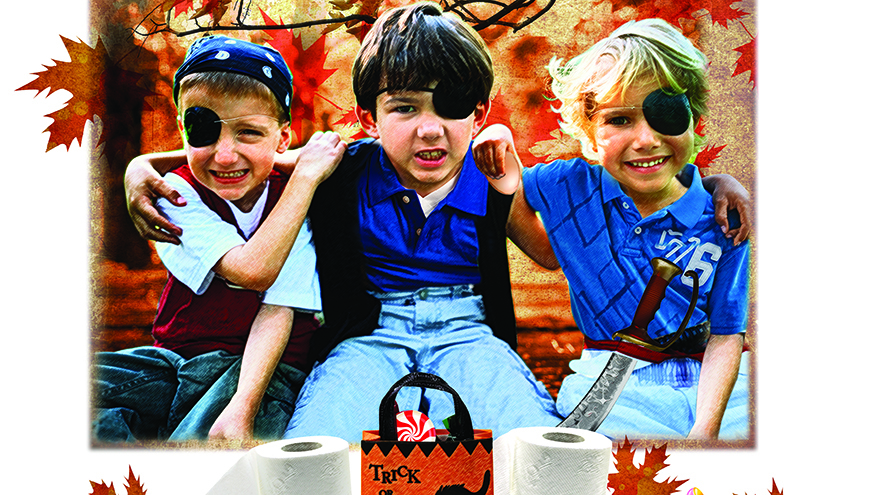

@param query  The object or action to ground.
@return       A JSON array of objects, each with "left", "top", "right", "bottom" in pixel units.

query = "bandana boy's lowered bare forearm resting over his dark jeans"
[{"left": 208, "top": 304, "right": 294, "bottom": 440}]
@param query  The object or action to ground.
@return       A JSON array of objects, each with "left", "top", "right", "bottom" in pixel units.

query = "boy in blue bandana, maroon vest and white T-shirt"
[{"left": 93, "top": 36, "right": 345, "bottom": 442}]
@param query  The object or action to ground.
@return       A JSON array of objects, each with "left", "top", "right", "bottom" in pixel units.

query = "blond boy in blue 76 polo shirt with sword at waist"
[{"left": 475, "top": 19, "right": 749, "bottom": 439}]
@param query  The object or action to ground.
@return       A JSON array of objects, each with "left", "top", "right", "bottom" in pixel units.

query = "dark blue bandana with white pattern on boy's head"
[{"left": 174, "top": 36, "right": 293, "bottom": 120}]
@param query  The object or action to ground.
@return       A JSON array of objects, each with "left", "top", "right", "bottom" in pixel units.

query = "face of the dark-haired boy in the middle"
[{"left": 357, "top": 86, "right": 489, "bottom": 196}]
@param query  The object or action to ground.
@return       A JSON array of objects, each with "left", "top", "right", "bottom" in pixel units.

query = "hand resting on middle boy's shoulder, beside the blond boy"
[{"left": 473, "top": 124, "right": 522, "bottom": 194}]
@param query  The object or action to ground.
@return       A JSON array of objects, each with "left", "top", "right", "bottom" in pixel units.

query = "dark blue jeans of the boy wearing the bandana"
[{"left": 92, "top": 347, "right": 305, "bottom": 442}]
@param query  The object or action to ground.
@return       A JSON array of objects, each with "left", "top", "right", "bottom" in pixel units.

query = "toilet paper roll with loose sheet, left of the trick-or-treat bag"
[{"left": 208, "top": 436, "right": 351, "bottom": 495}]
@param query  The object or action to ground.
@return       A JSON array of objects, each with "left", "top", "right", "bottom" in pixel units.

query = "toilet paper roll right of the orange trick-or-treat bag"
[{"left": 493, "top": 427, "right": 611, "bottom": 495}]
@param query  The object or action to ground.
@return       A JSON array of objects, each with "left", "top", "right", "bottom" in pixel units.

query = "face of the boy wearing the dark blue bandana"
[{"left": 178, "top": 87, "right": 290, "bottom": 211}]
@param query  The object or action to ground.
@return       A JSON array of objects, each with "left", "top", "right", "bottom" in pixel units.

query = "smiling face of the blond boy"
[{"left": 592, "top": 83, "right": 694, "bottom": 207}]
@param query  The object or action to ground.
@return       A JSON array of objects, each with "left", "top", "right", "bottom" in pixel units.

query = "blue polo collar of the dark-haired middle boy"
[{"left": 367, "top": 141, "right": 489, "bottom": 216}]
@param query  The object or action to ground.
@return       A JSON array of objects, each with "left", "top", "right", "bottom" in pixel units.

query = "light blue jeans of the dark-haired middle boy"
[{"left": 284, "top": 286, "right": 561, "bottom": 443}]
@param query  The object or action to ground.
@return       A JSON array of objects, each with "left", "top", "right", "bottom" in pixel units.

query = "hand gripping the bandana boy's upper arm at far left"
[{"left": 124, "top": 156, "right": 186, "bottom": 244}]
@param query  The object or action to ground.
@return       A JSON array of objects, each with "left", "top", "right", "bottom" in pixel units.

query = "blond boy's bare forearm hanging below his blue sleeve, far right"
[{"left": 688, "top": 333, "right": 743, "bottom": 439}]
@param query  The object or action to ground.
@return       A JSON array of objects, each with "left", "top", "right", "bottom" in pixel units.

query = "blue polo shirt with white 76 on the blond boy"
[{"left": 523, "top": 159, "right": 749, "bottom": 340}]
